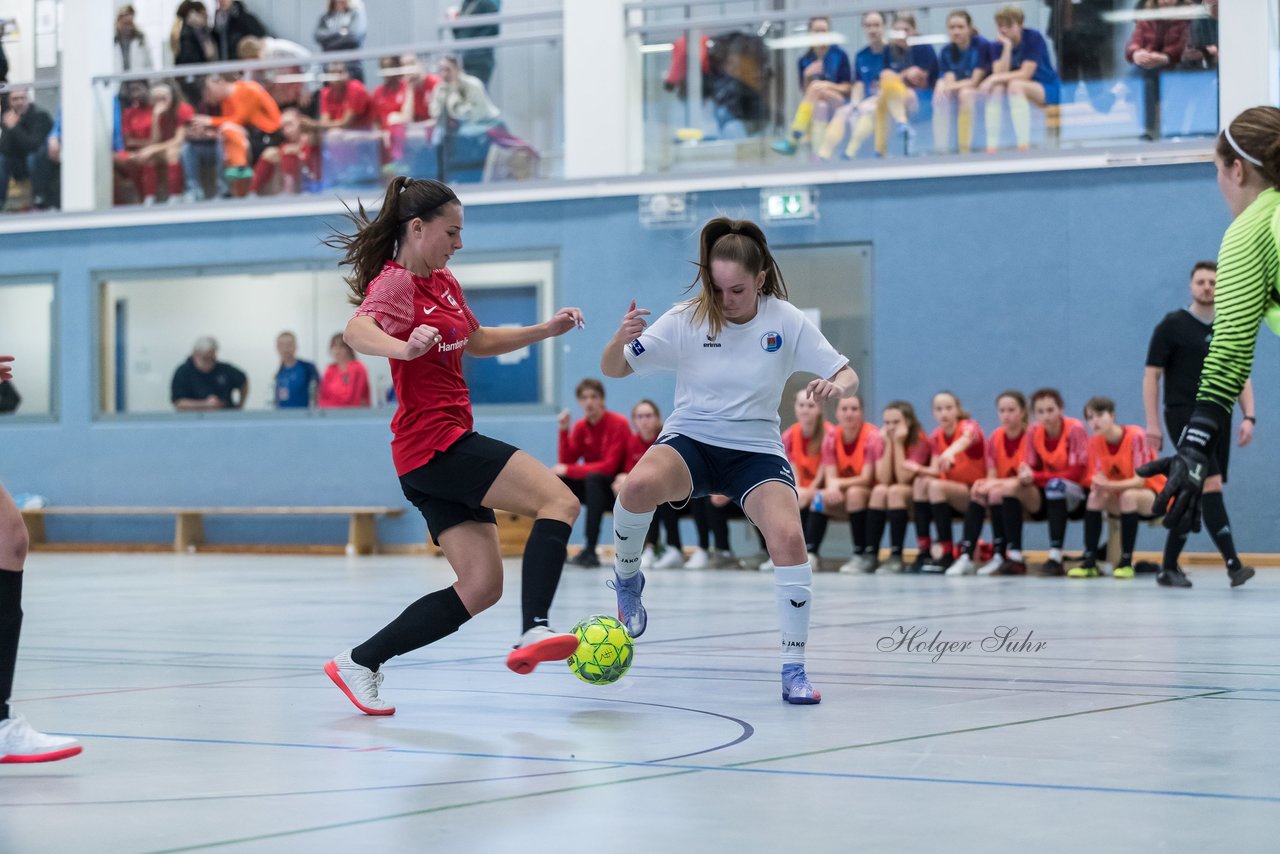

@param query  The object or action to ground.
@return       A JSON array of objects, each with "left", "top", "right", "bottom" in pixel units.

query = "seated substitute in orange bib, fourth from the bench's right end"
[{"left": 915, "top": 392, "right": 987, "bottom": 572}]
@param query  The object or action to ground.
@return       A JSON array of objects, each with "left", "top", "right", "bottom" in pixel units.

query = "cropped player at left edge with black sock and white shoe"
[{"left": 0, "top": 356, "right": 81, "bottom": 764}]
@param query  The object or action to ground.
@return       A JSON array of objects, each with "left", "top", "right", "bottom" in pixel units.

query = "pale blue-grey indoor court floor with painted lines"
[{"left": 0, "top": 553, "right": 1280, "bottom": 854}]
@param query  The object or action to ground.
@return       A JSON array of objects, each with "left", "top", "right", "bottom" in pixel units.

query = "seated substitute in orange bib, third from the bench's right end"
[{"left": 962, "top": 389, "right": 1027, "bottom": 575}]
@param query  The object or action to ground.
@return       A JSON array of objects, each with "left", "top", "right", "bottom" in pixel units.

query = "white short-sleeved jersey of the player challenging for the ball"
[{"left": 623, "top": 297, "right": 849, "bottom": 458}]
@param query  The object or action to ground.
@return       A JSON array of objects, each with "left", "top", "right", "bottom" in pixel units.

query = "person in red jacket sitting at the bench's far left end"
[{"left": 552, "top": 376, "right": 631, "bottom": 568}]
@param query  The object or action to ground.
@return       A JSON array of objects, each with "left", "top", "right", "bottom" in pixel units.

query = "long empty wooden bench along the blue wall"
[{"left": 22, "top": 507, "right": 404, "bottom": 554}]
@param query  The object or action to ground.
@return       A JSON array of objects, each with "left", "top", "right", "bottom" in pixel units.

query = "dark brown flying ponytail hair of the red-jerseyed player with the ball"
[{"left": 321, "top": 175, "right": 462, "bottom": 306}]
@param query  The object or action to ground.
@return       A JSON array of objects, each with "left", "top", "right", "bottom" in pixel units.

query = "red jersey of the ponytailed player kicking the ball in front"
[{"left": 356, "top": 261, "right": 480, "bottom": 475}]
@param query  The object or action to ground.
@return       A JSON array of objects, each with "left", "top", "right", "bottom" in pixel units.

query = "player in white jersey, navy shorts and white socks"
[{"left": 600, "top": 216, "right": 858, "bottom": 704}]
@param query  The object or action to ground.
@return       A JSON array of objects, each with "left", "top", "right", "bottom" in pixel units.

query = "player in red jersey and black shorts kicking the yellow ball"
[{"left": 325, "top": 177, "right": 582, "bottom": 714}]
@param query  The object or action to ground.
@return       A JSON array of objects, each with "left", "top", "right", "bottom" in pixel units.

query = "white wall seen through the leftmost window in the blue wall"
[{"left": 0, "top": 283, "right": 54, "bottom": 415}]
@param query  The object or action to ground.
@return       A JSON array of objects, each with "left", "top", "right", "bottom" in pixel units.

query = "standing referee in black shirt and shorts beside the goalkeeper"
[{"left": 1142, "top": 261, "right": 1256, "bottom": 588}]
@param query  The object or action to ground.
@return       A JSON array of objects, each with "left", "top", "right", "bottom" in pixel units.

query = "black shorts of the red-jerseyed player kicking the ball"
[{"left": 401, "top": 433, "right": 518, "bottom": 545}]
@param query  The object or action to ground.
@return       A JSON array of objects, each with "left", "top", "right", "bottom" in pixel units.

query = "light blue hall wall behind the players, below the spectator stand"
[{"left": 0, "top": 165, "right": 1280, "bottom": 552}]
